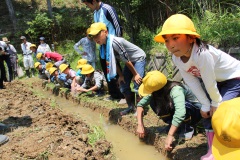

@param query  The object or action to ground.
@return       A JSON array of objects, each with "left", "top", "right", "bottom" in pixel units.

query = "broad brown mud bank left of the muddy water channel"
[{"left": 0, "top": 79, "right": 113, "bottom": 160}]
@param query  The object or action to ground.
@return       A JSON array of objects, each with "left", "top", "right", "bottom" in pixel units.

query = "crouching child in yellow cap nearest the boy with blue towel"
[{"left": 77, "top": 64, "right": 103, "bottom": 94}]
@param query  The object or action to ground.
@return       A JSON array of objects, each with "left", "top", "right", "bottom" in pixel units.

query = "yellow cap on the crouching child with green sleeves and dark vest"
[{"left": 138, "top": 70, "right": 167, "bottom": 96}]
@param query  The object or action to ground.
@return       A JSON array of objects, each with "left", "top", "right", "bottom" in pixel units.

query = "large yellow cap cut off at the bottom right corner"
[{"left": 212, "top": 98, "right": 240, "bottom": 160}]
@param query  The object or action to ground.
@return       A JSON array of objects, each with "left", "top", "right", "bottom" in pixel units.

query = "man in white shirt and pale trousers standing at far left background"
[{"left": 20, "top": 36, "right": 34, "bottom": 78}]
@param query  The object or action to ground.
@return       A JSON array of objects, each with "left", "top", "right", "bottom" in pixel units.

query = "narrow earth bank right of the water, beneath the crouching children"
[{"left": 40, "top": 79, "right": 207, "bottom": 160}]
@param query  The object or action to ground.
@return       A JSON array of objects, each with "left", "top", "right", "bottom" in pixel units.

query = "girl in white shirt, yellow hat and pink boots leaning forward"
[{"left": 154, "top": 14, "right": 240, "bottom": 160}]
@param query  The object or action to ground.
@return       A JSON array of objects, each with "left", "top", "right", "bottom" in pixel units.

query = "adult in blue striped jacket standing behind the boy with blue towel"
[{"left": 82, "top": 0, "right": 124, "bottom": 99}]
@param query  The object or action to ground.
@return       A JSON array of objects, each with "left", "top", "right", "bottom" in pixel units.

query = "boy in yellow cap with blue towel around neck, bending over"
[{"left": 89, "top": 22, "right": 146, "bottom": 115}]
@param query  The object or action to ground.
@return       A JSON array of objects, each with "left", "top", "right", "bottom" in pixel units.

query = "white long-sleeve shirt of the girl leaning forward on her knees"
[{"left": 172, "top": 44, "right": 240, "bottom": 112}]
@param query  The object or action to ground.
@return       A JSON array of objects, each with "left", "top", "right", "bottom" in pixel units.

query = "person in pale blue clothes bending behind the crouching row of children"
[{"left": 74, "top": 29, "right": 97, "bottom": 69}]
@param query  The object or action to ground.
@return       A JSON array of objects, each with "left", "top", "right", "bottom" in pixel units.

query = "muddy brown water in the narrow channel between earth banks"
[{"left": 51, "top": 97, "right": 167, "bottom": 160}]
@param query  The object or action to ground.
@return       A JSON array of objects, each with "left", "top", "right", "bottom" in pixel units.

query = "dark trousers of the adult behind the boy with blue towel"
[{"left": 99, "top": 57, "right": 124, "bottom": 99}]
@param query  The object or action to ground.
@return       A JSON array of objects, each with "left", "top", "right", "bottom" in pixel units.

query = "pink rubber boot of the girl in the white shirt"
[{"left": 201, "top": 130, "right": 214, "bottom": 160}]
